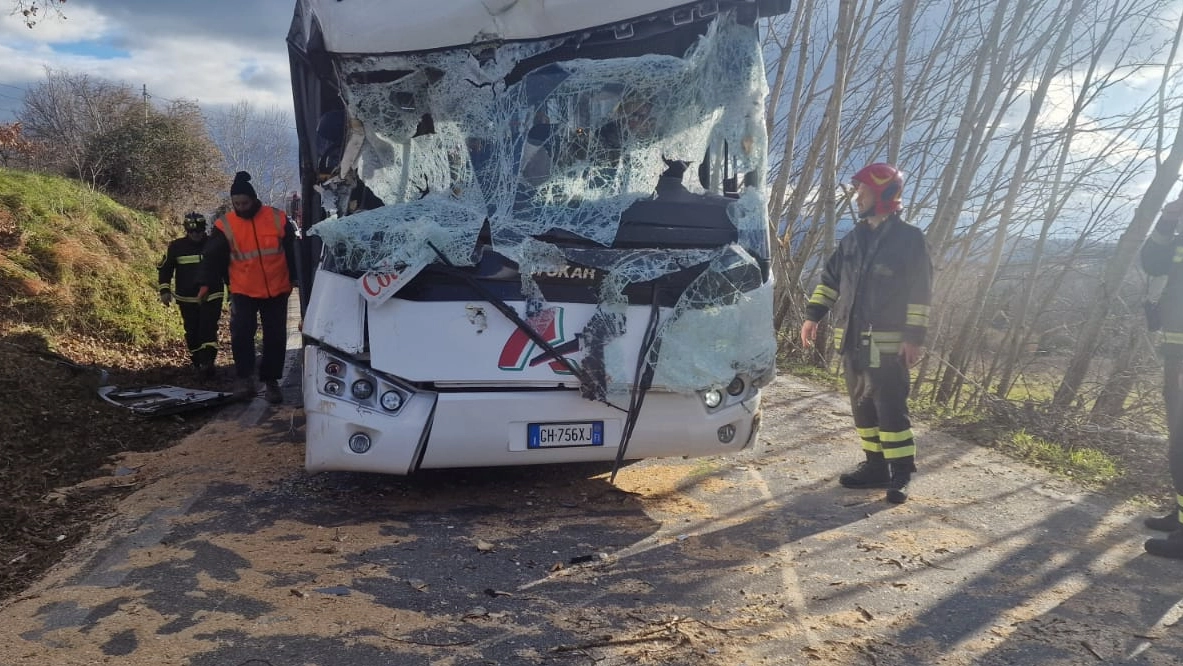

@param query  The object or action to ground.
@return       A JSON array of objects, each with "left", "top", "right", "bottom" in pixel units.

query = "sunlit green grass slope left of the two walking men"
[{"left": 0, "top": 169, "right": 180, "bottom": 345}]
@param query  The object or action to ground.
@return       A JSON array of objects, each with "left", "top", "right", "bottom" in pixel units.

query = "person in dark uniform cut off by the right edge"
[{"left": 1142, "top": 196, "right": 1183, "bottom": 560}]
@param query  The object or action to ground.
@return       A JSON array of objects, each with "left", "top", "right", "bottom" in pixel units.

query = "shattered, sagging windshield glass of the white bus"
[{"left": 312, "top": 14, "right": 775, "bottom": 390}]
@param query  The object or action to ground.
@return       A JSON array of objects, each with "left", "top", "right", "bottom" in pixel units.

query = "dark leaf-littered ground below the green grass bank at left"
[{"left": 0, "top": 331, "right": 211, "bottom": 597}]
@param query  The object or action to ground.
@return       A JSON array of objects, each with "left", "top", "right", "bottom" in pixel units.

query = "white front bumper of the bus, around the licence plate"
[{"left": 304, "top": 345, "right": 761, "bottom": 474}]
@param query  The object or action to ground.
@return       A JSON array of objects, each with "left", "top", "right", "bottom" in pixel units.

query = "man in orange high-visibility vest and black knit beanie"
[{"left": 201, "top": 172, "right": 296, "bottom": 405}]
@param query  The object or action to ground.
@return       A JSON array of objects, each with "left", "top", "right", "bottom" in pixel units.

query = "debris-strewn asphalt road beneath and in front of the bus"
[{"left": 0, "top": 366, "right": 1183, "bottom": 666}]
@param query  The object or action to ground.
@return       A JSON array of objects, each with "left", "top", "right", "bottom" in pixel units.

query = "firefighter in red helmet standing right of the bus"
[{"left": 801, "top": 163, "right": 932, "bottom": 504}]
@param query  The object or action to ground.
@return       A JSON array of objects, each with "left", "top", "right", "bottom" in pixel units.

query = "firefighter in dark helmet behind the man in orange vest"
[{"left": 156, "top": 213, "right": 224, "bottom": 380}]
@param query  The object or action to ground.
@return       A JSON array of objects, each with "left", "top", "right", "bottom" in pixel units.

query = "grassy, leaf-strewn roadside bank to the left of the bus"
[{"left": 0, "top": 169, "right": 218, "bottom": 597}]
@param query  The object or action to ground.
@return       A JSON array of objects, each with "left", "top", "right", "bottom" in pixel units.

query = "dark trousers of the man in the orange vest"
[{"left": 230, "top": 293, "right": 289, "bottom": 381}]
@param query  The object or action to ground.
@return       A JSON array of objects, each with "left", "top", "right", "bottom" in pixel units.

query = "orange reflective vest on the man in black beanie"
[{"left": 214, "top": 206, "right": 292, "bottom": 298}]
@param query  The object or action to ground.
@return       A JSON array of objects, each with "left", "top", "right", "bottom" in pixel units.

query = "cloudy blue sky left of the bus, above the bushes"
[{"left": 0, "top": 0, "right": 296, "bottom": 122}]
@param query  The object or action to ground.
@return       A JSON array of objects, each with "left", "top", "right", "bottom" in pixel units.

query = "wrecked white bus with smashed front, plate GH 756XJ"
[{"left": 289, "top": 0, "right": 788, "bottom": 474}]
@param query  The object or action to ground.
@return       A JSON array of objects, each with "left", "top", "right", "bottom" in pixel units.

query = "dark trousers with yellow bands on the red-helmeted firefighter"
[{"left": 842, "top": 354, "right": 916, "bottom": 472}]
